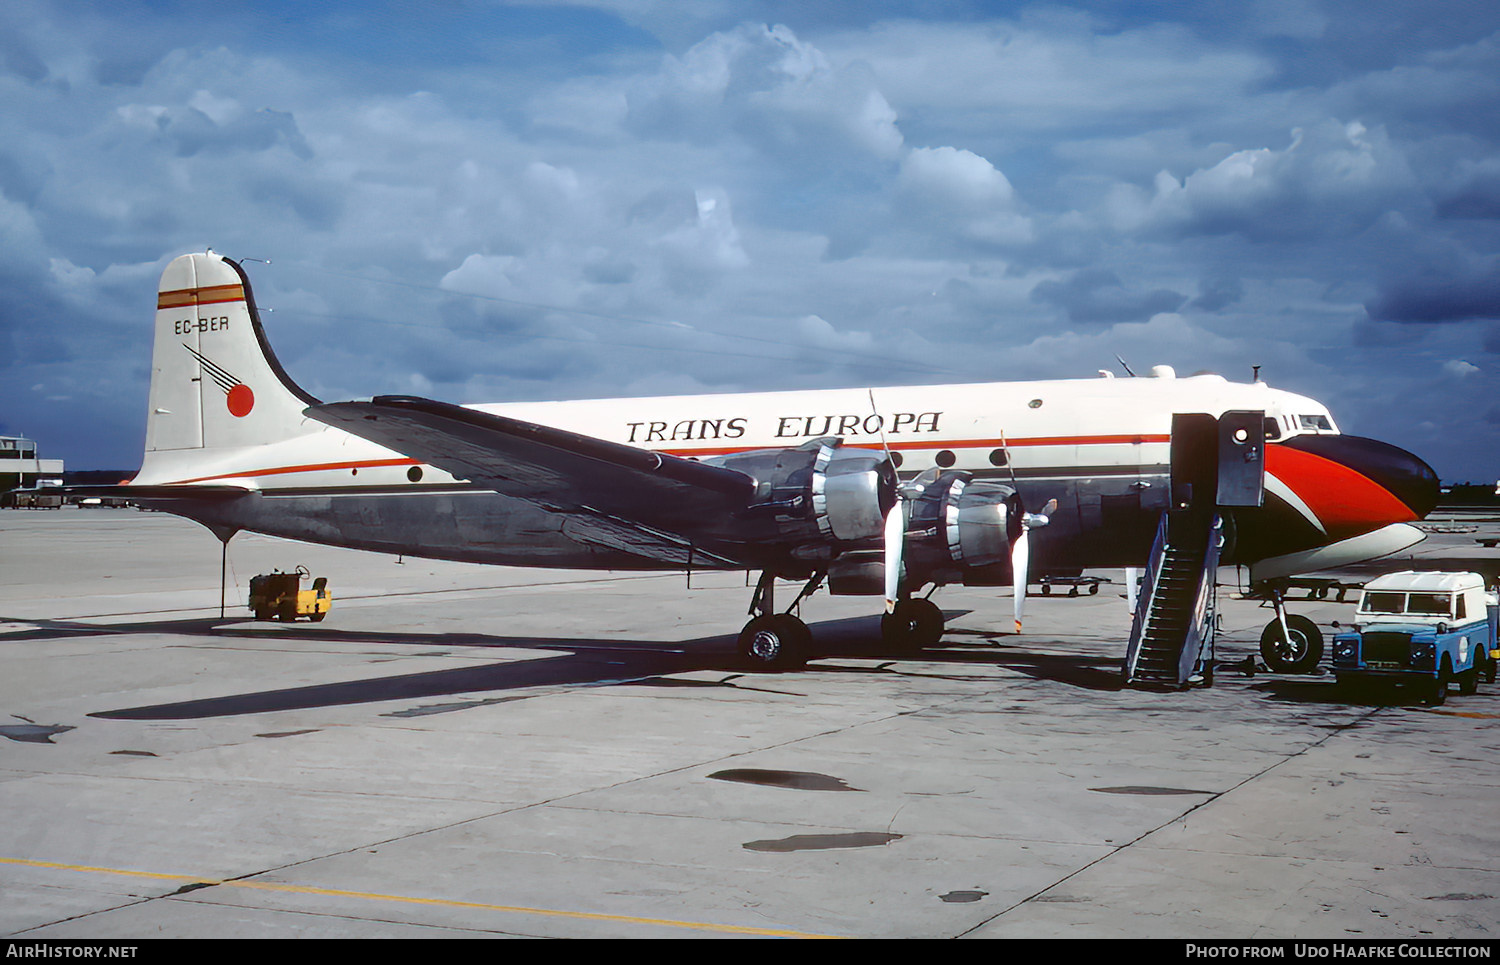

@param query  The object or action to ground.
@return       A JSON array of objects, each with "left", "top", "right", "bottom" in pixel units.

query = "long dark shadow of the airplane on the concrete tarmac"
[{"left": 5, "top": 611, "right": 1121, "bottom": 720}]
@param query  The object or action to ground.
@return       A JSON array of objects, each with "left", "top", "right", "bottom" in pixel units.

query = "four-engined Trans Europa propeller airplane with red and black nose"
[{"left": 90, "top": 251, "right": 1439, "bottom": 669}]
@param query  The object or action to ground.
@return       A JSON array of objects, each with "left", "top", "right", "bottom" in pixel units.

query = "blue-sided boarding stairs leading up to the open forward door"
[{"left": 1125, "top": 512, "right": 1224, "bottom": 689}]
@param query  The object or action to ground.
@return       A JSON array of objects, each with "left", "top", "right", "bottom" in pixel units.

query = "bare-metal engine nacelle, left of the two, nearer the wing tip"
[{"left": 708, "top": 438, "right": 896, "bottom": 543}]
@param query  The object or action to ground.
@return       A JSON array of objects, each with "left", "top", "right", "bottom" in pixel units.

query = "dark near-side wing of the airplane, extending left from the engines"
[{"left": 306, "top": 396, "right": 756, "bottom": 566}]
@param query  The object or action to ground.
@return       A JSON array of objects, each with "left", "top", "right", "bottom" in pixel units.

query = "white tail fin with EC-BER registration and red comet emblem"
[{"left": 143, "top": 252, "right": 318, "bottom": 456}]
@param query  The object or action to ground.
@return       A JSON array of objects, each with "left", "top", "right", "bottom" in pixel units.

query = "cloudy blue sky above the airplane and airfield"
[{"left": 0, "top": 0, "right": 1500, "bottom": 482}]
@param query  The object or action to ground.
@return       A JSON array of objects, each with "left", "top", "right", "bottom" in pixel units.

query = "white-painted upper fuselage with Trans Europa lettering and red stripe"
[{"left": 135, "top": 375, "right": 1337, "bottom": 492}]
